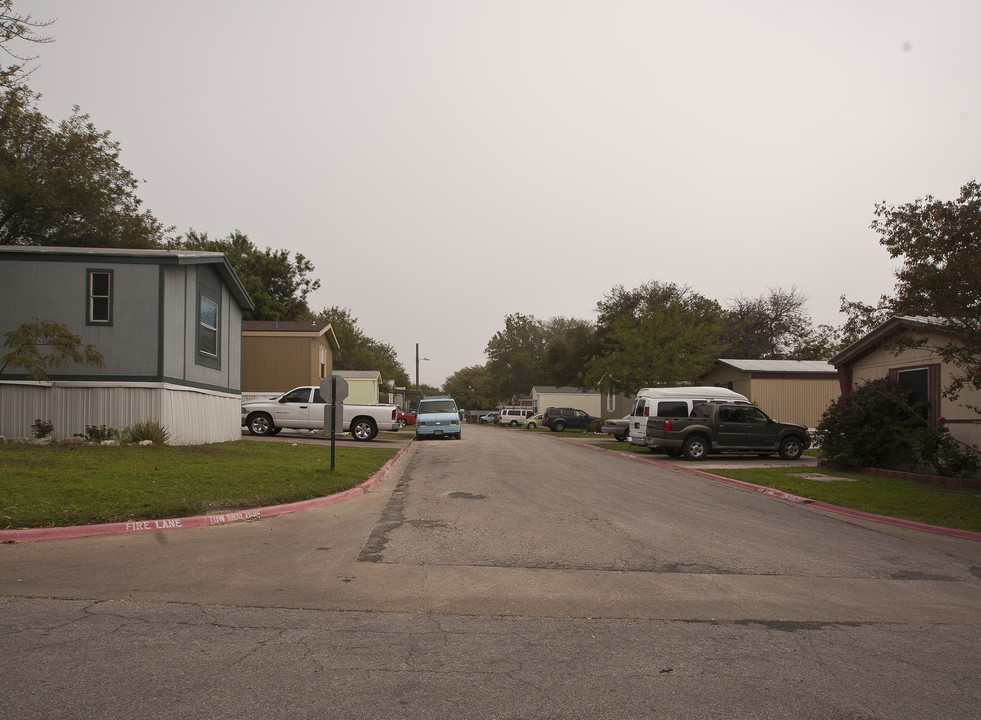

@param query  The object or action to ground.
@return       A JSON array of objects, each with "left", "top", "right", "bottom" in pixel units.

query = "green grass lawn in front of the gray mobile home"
[{"left": 0, "top": 440, "right": 397, "bottom": 529}]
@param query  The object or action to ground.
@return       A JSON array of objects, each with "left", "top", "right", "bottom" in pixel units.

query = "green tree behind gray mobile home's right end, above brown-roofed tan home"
[{"left": 177, "top": 230, "right": 320, "bottom": 320}]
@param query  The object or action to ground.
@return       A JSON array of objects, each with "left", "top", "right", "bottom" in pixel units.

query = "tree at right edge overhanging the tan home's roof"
[{"left": 871, "top": 180, "right": 981, "bottom": 397}]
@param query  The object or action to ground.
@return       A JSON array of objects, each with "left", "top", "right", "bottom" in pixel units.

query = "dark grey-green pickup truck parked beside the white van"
[{"left": 647, "top": 402, "right": 811, "bottom": 460}]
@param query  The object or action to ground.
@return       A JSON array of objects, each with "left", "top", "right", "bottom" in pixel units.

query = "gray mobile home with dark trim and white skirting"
[{"left": 0, "top": 246, "right": 253, "bottom": 444}]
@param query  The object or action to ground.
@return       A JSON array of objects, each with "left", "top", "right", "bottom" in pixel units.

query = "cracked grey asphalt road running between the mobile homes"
[{"left": 0, "top": 425, "right": 981, "bottom": 720}]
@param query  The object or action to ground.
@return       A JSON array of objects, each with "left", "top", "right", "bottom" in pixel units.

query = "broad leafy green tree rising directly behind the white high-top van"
[{"left": 586, "top": 281, "right": 723, "bottom": 394}]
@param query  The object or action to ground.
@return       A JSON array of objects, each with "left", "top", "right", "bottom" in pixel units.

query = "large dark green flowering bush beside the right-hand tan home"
[{"left": 817, "top": 378, "right": 981, "bottom": 477}]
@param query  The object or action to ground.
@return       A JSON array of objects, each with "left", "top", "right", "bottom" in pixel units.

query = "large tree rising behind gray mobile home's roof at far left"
[{"left": 0, "top": 87, "right": 169, "bottom": 248}]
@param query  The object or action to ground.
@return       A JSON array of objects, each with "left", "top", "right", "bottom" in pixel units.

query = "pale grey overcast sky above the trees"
[{"left": 23, "top": 0, "right": 981, "bottom": 385}]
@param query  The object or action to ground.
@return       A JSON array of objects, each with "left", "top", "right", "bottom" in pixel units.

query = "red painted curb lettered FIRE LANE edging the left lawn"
[{"left": 0, "top": 448, "right": 405, "bottom": 543}]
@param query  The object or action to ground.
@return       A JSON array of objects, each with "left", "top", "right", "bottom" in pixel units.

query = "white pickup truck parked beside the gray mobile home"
[{"left": 242, "top": 385, "right": 399, "bottom": 440}]
